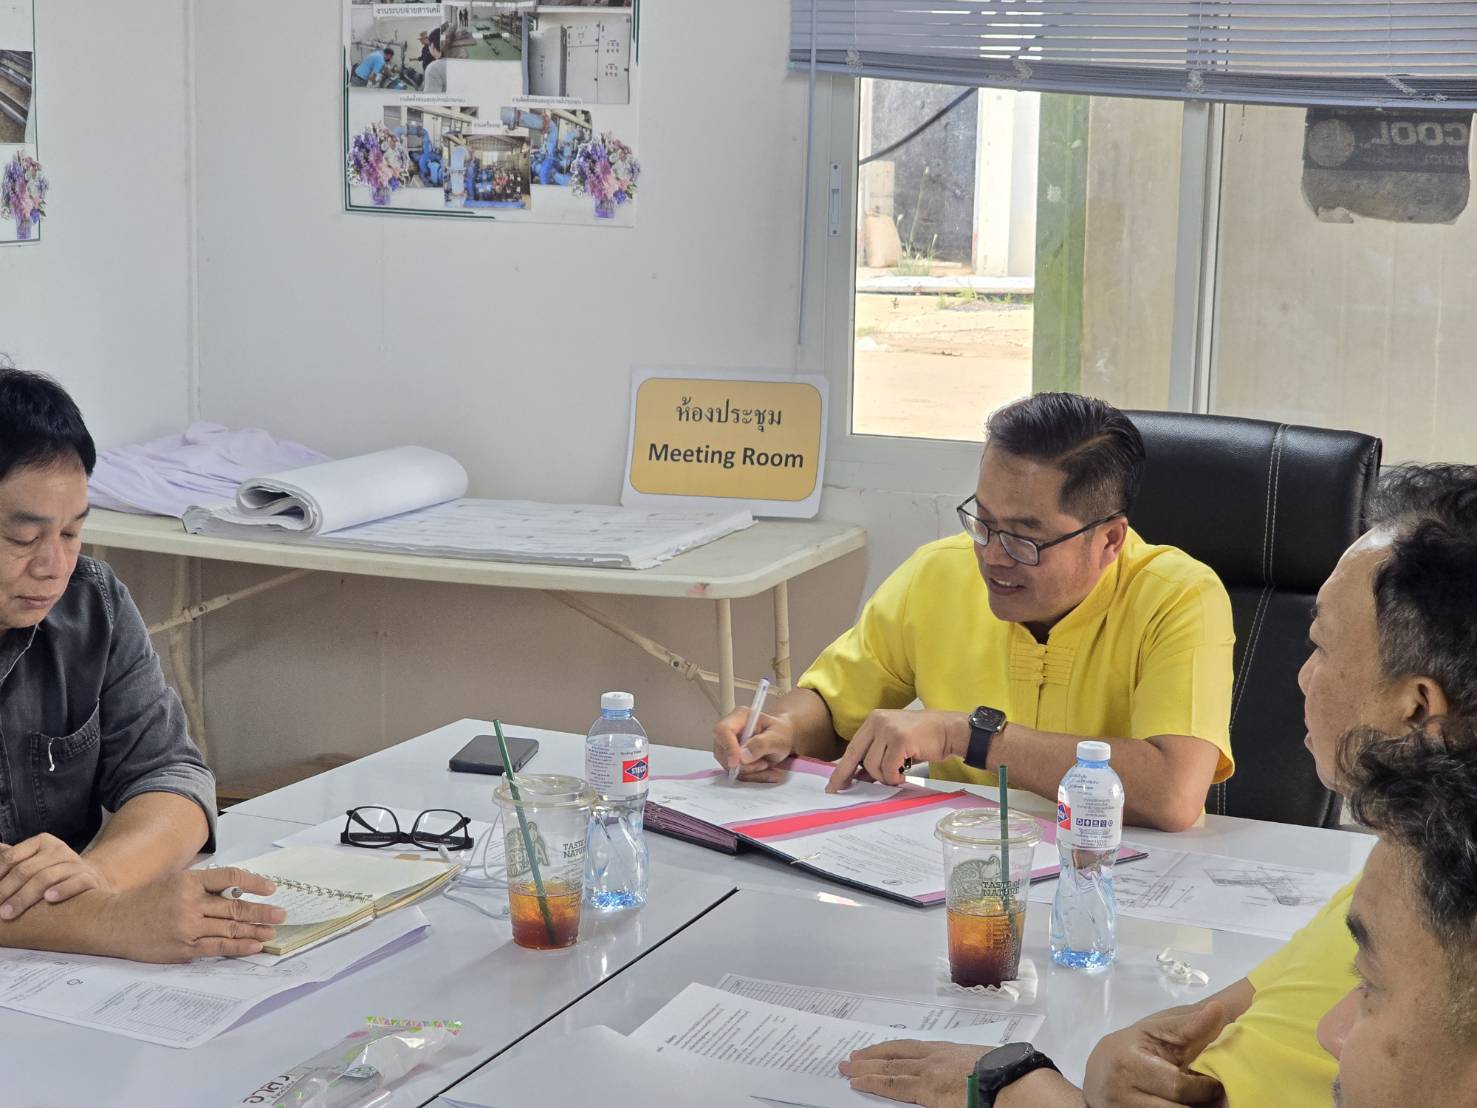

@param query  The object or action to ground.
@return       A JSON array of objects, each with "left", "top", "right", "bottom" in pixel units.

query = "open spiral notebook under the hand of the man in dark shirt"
[{"left": 232, "top": 847, "right": 459, "bottom": 954}]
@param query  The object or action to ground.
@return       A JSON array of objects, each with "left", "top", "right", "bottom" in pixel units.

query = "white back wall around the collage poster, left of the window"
[{"left": 196, "top": 0, "right": 805, "bottom": 502}]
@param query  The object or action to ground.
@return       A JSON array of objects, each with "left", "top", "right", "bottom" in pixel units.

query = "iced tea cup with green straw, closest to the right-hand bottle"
[{"left": 933, "top": 808, "right": 1041, "bottom": 988}]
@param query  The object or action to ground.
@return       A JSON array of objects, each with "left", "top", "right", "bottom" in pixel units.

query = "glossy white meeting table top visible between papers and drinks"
[{"left": 0, "top": 719, "right": 1372, "bottom": 1108}]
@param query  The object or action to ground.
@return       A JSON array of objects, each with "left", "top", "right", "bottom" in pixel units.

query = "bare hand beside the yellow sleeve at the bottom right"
[{"left": 1083, "top": 1000, "right": 1226, "bottom": 1108}]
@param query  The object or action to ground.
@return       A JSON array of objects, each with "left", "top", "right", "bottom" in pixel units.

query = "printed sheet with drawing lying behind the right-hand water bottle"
[{"left": 1031, "top": 849, "right": 1353, "bottom": 940}]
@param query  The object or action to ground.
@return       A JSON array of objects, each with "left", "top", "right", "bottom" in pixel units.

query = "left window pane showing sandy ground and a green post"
[{"left": 851, "top": 80, "right": 1182, "bottom": 442}]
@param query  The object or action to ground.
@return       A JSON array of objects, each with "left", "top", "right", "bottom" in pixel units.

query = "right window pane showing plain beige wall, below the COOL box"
[{"left": 1211, "top": 106, "right": 1477, "bottom": 461}]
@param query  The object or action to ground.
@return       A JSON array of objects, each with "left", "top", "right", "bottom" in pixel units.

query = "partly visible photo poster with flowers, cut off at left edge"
[{"left": 0, "top": 0, "right": 39, "bottom": 245}]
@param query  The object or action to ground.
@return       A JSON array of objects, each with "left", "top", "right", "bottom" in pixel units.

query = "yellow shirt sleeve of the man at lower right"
[{"left": 1192, "top": 879, "right": 1359, "bottom": 1108}]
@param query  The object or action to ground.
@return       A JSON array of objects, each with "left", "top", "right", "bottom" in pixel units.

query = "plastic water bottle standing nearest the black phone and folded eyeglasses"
[{"left": 585, "top": 693, "right": 650, "bottom": 912}]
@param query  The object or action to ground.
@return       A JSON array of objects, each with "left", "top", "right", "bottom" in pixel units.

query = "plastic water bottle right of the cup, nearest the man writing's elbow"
[{"left": 1052, "top": 742, "right": 1123, "bottom": 969}]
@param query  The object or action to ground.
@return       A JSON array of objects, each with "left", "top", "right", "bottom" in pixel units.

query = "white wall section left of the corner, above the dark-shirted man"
[{"left": 0, "top": 0, "right": 192, "bottom": 446}]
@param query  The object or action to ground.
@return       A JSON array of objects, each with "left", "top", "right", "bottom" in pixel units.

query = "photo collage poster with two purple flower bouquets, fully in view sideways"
[{"left": 348, "top": 0, "right": 641, "bottom": 226}]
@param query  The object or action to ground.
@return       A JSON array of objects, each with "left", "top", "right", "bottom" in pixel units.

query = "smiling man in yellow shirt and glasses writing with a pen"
[{"left": 713, "top": 393, "right": 1235, "bottom": 830}]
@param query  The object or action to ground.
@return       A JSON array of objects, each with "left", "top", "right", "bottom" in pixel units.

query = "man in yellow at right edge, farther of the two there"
[{"left": 848, "top": 465, "right": 1477, "bottom": 1108}]
